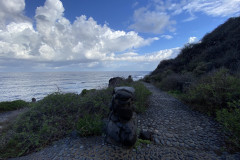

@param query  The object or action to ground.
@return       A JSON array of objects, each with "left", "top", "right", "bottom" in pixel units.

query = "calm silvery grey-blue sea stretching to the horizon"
[{"left": 0, "top": 71, "right": 149, "bottom": 101}]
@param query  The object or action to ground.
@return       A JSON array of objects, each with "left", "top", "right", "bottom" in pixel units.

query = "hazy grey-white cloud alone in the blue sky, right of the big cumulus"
[{"left": 129, "top": 7, "right": 176, "bottom": 34}]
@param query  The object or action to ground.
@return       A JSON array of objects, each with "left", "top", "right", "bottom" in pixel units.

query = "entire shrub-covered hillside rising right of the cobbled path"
[{"left": 144, "top": 17, "right": 240, "bottom": 150}]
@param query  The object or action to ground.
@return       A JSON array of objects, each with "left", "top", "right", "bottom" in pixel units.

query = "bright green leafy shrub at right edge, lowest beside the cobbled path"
[{"left": 217, "top": 100, "right": 240, "bottom": 149}]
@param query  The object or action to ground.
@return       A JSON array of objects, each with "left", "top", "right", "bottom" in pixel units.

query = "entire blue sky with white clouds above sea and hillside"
[{"left": 0, "top": 0, "right": 240, "bottom": 72}]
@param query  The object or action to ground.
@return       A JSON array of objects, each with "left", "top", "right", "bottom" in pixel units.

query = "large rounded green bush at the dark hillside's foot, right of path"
[{"left": 183, "top": 69, "right": 240, "bottom": 115}]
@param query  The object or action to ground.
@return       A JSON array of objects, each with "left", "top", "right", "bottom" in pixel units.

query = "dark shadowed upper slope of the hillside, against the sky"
[{"left": 150, "top": 17, "right": 240, "bottom": 80}]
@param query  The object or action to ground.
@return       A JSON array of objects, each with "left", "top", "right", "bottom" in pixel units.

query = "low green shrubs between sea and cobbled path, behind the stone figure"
[{"left": 0, "top": 82, "right": 150, "bottom": 158}]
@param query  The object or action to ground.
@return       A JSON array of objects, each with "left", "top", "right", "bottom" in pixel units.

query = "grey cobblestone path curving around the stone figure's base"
[{"left": 11, "top": 83, "right": 240, "bottom": 160}]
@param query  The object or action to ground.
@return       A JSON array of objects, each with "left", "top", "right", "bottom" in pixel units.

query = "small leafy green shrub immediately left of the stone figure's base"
[{"left": 76, "top": 114, "right": 103, "bottom": 136}]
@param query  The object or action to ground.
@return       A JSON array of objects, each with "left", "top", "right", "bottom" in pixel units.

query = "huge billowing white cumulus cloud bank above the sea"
[{"left": 0, "top": 0, "right": 167, "bottom": 68}]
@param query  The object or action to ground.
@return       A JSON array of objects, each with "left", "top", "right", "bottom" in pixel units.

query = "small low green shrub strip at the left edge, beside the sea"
[{"left": 0, "top": 100, "right": 29, "bottom": 113}]
